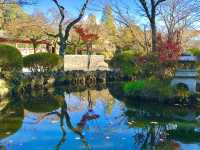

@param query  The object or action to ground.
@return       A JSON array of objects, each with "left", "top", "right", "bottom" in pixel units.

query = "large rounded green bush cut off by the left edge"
[{"left": 0, "top": 45, "right": 23, "bottom": 80}]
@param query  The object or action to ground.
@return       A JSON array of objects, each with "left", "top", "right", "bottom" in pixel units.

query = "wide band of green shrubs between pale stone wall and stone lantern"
[{"left": 110, "top": 50, "right": 177, "bottom": 80}]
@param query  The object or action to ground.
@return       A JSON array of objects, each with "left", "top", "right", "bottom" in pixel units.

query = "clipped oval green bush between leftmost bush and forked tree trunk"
[{"left": 23, "top": 53, "right": 60, "bottom": 72}]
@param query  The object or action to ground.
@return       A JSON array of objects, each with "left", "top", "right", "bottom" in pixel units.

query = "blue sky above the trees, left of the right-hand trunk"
[{"left": 24, "top": 0, "right": 147, "bottom": 25}]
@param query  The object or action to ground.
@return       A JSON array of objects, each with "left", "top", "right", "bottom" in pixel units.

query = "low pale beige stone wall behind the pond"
[{"left": 64, "top": 55, "right": 109, "bottom": 71}]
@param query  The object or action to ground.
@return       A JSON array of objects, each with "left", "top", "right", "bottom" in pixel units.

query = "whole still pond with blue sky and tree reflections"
[{"left": 0, "top": 87, "right": 200, "bottom": 150}]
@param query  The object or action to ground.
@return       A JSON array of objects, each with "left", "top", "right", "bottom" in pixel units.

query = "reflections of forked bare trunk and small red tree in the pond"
[{"left": 34, "top": 90, "right": 99, "bottom": 150}]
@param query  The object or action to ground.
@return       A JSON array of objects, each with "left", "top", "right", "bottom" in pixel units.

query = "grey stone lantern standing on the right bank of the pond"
[{"left": 171, "top": 53, "right": 198, "bottom": 93}]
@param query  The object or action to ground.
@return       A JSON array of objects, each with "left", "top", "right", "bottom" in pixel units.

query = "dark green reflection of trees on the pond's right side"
[{"left": 125, "top": 100, "right": 200, "bottom": 150}]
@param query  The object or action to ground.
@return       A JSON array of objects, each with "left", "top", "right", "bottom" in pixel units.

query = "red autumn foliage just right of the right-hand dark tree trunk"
[{"left": 157, "top": 34, "right": 182, "bottom": 63}]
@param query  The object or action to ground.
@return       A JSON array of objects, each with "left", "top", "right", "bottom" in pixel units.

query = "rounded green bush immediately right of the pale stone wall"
[{"left": 110, "top": 50, "right": 139, "bottom": 76}]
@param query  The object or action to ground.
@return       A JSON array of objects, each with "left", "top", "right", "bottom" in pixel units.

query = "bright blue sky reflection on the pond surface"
[{"left": 0, "top": 91, "right": 200, "bottom": 150}]
